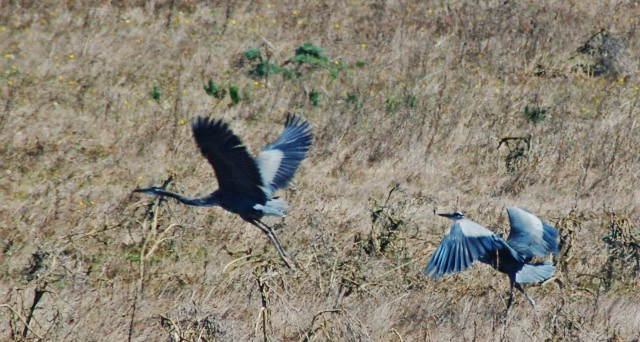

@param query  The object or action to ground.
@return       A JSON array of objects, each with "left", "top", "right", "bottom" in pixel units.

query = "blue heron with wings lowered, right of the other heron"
[{"left": 423, "top": 207, "right": 558, "bottom": 309}]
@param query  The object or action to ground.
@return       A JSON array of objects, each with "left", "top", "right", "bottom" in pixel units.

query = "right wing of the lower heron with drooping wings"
[{"left": 507, "top": 207, "right": 558, "bottom": 258}]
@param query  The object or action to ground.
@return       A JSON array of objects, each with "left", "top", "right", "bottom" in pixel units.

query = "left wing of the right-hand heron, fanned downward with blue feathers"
[{"left": 423, "top": 219, "right": 504, "bottom": 278}]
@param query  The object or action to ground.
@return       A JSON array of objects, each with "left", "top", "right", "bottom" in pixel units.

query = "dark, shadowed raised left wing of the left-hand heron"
[{"left": 192, "top": 117, "right": 266, "bottom": 202}]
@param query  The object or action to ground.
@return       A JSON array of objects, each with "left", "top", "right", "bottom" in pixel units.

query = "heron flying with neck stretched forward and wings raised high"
[{"left": 134, "top": 115, "right": 311, "bottom": 269}]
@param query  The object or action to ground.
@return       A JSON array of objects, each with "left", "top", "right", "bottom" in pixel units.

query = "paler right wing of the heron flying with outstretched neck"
[{"left": 256, "top": 115, "right": 311, "bottom": 194}]
